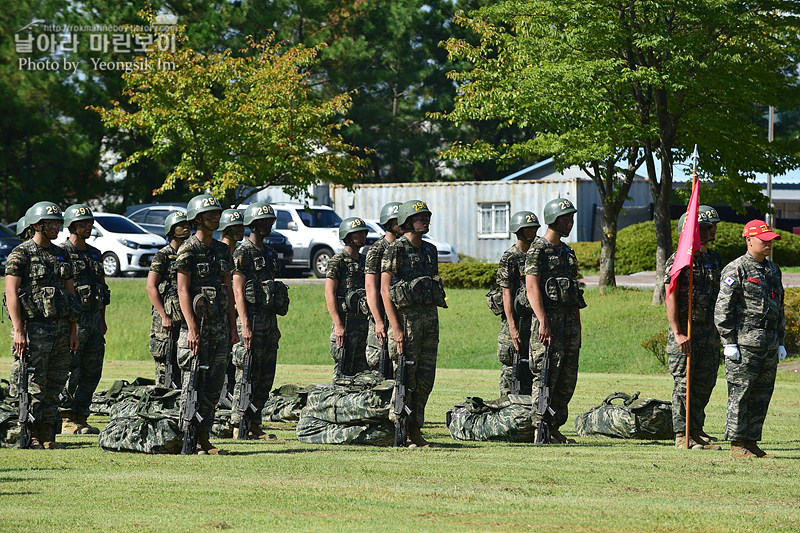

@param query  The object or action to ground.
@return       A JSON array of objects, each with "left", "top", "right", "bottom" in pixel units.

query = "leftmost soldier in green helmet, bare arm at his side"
[{"left": 5, "top": 202, "right": 81, "bottom": 449}]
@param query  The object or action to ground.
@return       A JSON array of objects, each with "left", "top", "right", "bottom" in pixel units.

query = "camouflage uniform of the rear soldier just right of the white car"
[{"left": 150, "top": 244, "right": 183, "bottom": 385}]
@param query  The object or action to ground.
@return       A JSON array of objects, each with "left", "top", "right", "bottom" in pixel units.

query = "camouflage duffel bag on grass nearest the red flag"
[{"left": 575, "top": 391, "right": 674, "bottom": 440}]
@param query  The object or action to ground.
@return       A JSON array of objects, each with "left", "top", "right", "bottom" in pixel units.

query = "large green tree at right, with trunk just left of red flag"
[{"left": 438, "top": 0, "right": 800, "bottom": 303}]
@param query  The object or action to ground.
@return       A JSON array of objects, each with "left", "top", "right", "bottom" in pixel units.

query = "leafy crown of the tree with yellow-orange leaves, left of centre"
[{"left": 93, "top": 18, "right": 366, "bottom": 204}]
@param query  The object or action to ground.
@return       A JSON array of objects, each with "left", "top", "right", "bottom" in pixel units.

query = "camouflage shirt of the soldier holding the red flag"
[{"left": 664, "top": 250, "right": 722, "bottom": 329}]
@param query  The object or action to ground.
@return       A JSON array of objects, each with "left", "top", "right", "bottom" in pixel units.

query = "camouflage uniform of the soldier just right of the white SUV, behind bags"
[{"left": 325, "top": 250, "right": 369, "bottom": 381}]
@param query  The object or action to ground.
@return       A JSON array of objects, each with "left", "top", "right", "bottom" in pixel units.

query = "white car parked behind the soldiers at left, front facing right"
[{"left": 58, "top": 212, "right": 167, "bottom": 277}]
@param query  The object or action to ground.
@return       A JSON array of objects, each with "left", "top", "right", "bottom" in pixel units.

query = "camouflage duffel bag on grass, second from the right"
[{"left": 446, "top": 394, "right": 533, "bottom": 442}]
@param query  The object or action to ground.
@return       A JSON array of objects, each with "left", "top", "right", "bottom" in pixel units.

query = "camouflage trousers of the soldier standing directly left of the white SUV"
[{"left": 231, "top": 311, "right": 278, "bottom": 426}]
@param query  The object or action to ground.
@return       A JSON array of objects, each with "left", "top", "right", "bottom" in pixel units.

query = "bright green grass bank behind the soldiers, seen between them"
[{"left": 0, "top": 278, "right": 680, "bottom": 374}]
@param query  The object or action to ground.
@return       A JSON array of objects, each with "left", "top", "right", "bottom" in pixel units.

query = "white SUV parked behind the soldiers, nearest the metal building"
[{"left": 270, "top": 203, "right": 344, "bottom": 278}]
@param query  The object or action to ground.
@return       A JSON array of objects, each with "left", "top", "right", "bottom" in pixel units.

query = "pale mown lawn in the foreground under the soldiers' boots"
[{"left": 0, "top": 357, "right": 800, "bottom": 533}]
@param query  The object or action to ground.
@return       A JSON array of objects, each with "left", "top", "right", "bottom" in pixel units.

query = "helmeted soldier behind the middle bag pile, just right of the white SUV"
[{"left": 325, "top": 217, "right": 369, "bottom": 383}]
